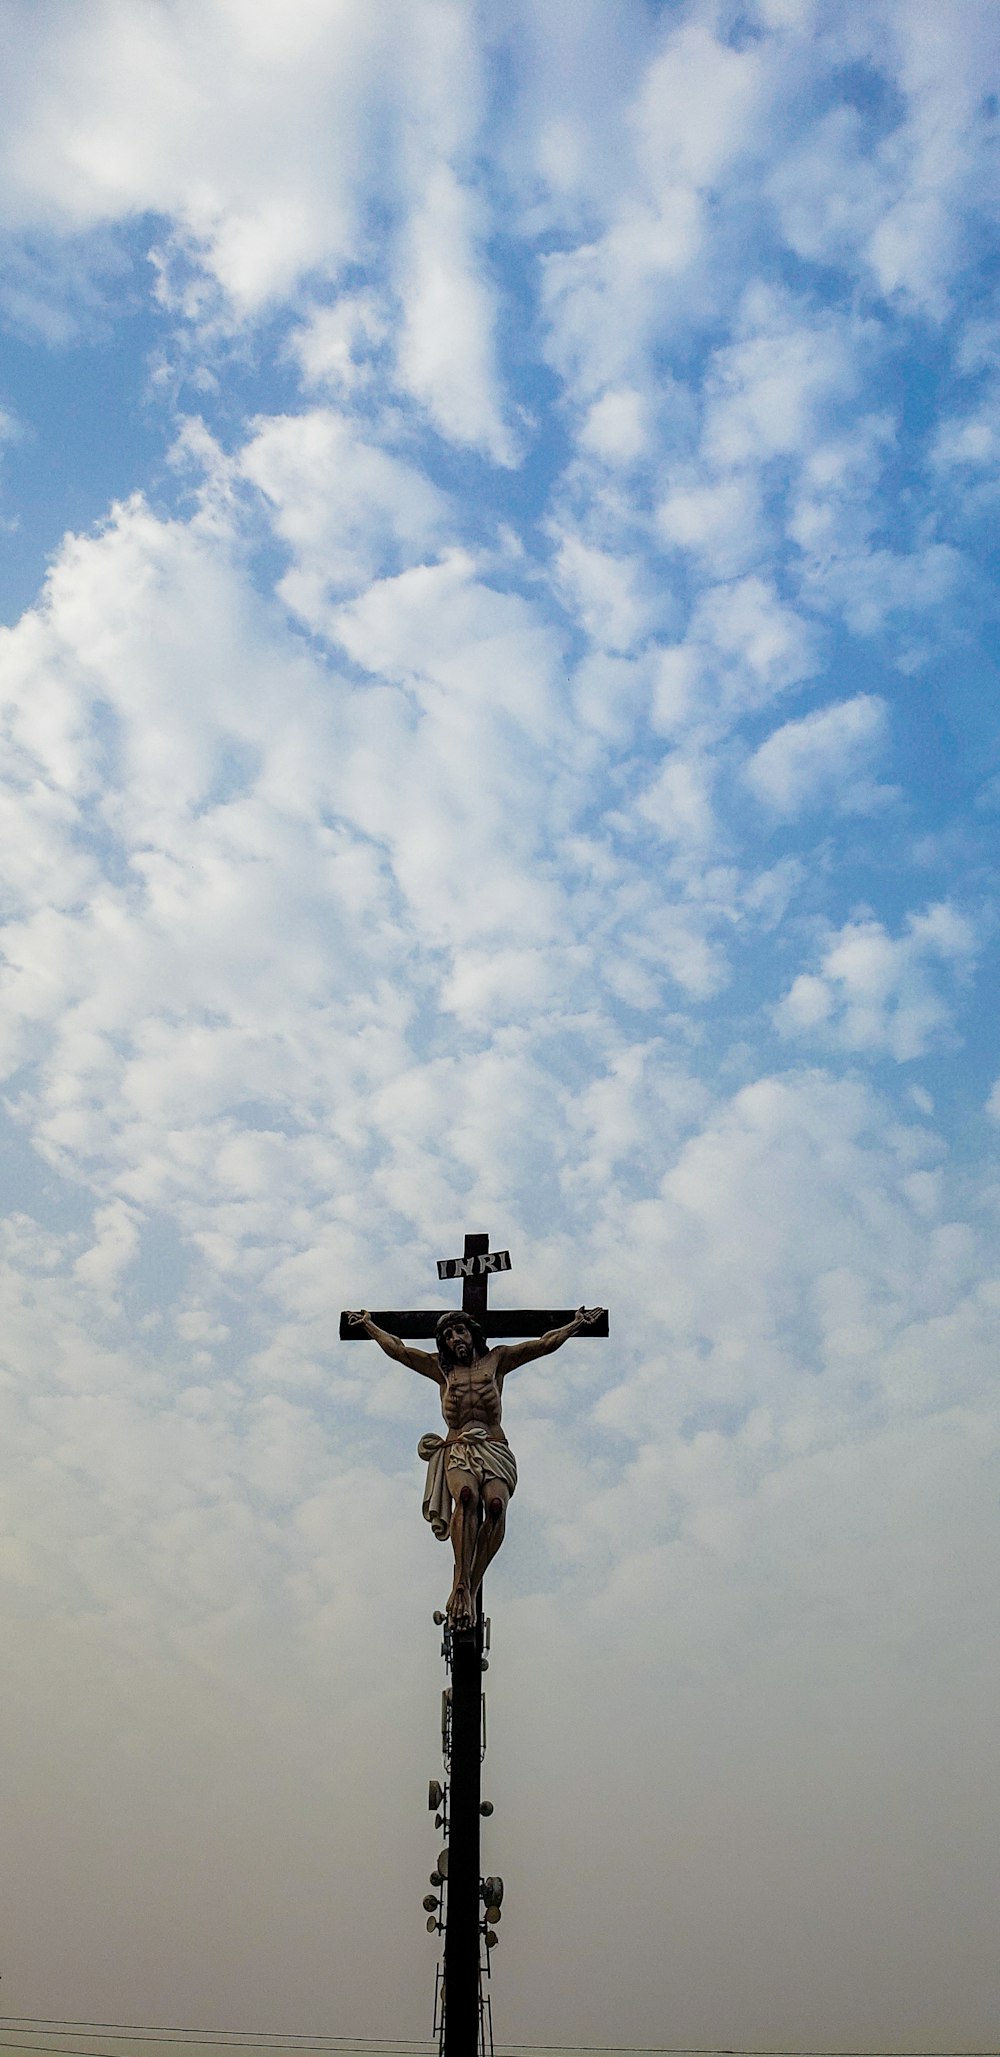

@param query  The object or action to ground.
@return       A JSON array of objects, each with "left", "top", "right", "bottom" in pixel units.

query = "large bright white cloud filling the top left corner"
[{"left": 4, "top": 0, "right": 395, "bottom": 311}]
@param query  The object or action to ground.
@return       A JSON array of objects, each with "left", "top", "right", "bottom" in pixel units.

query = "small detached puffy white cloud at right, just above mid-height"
[{"left": 776, "top": 901, "right": 975, "bottom": 1063}]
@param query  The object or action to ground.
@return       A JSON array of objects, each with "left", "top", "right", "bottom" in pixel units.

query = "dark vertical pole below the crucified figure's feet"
[{"left": 444, "top": 1592, "right": 484, "bottom": 2057}]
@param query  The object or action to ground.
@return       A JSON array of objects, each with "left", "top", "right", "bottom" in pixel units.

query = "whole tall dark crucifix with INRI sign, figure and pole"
[{"left": 340, "top": 1234, "right": 607, "bottom": 2057}]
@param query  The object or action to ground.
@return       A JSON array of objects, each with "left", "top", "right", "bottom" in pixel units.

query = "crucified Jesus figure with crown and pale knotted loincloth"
[{"left": 350, "top": 1306, "right": 603, "bottom": 1629}]
